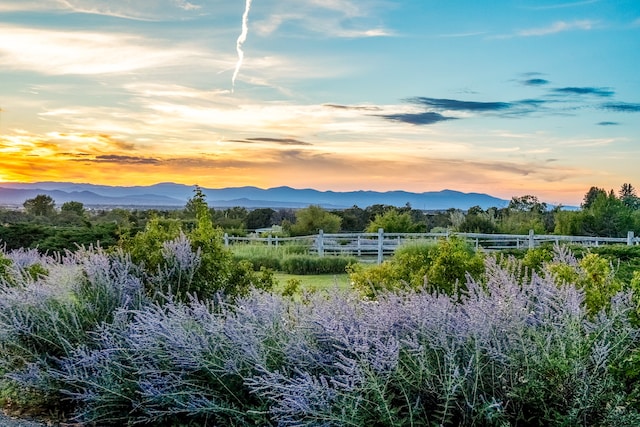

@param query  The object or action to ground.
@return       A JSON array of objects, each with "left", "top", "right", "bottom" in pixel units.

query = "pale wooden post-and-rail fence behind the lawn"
[{"left": 224, "top": 229, "right": 640, "bottom": 263}]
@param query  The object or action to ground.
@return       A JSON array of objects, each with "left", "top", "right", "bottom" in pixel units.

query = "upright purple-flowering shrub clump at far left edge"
[{"left": 0, "top": 248, "right": 143, "bottom": 416}]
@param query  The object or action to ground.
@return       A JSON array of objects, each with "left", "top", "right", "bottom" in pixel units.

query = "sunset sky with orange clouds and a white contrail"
[{"left": 0, "top": 0, "right": 640, "bottom": 205}]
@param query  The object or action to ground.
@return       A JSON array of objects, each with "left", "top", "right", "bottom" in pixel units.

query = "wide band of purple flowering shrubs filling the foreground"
[{"left": 0, "top": 242, "right": 640, "bottom": 426}]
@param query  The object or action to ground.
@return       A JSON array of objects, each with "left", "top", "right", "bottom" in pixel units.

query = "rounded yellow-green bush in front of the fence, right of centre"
[{"left": 349, "top": 237, "right": 484, "bottom": 298}]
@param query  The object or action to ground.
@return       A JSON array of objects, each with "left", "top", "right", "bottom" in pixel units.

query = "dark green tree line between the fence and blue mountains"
[{"left": 0, "top": 183, "right": 640, "bottom": 251}]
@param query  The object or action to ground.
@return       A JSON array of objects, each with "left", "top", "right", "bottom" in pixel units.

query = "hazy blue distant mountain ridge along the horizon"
[{"left": 0, "top": 182, "right": 509, "bottom": 210}]
